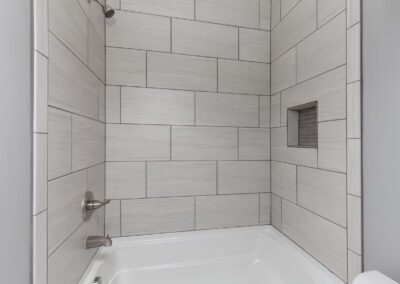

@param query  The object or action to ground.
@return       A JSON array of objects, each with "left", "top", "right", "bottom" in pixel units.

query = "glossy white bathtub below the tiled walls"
[{"left": 80, "top": 226, "right": 344, "bottom": 284}]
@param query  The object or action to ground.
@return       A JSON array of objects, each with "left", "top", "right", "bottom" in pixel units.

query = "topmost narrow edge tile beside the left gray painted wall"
[{"left": 33, "top": 0, "right": 49, "bottom": 56}]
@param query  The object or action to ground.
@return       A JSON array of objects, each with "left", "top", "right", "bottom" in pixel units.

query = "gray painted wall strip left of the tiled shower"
[{"left": 0, "top": 0, "right": 32, "bottom": 284}]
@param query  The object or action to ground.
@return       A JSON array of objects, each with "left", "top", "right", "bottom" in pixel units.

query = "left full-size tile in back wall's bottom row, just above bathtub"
[{"left": 121, "top": 197, "right": 194, "bottom": 236}]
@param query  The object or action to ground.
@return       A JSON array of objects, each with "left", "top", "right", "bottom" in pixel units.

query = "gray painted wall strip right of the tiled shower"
[{"left": 363, "top": 0, "right": 400, "bottom": 281}]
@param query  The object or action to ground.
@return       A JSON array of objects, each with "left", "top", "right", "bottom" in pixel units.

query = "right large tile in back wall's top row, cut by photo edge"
[{"left": 196, "top": 0, "right": 259, "bottom": 28}]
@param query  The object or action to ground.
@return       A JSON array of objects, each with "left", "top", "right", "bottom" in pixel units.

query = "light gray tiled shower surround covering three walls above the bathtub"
[{"left": 33, "top": 0, "right": 362, "bottom": 284}]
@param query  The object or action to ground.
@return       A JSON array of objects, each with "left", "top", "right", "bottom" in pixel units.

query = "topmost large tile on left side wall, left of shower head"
[{"left": 49, "top": 0, "right": 88, "bottom": 62}]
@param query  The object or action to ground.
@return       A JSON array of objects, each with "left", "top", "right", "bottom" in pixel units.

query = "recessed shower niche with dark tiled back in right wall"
[{"left": 287, "top": 101, "right": 318, "bottom": 148}]
